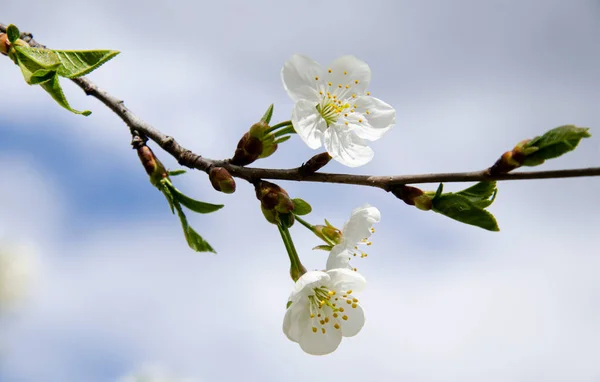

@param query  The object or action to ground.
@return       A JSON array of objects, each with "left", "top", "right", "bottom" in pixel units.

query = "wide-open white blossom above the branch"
[{"left": 281, "top": 54, "right": 396, "bottom": 167}]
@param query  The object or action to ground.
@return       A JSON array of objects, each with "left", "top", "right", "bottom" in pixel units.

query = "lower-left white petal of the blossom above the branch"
[{"left": 292, "top": 100, "right": 327, "bottom": 150}]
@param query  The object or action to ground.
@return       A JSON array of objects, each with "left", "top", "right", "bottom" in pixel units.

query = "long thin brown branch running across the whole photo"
[{"left": 0, "top": 24, "right": 600, "bottom": 191}]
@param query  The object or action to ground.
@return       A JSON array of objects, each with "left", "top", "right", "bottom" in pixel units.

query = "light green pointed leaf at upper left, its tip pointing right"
[{"left": 52, "top": 50, "right": 120, "bottom": 78}]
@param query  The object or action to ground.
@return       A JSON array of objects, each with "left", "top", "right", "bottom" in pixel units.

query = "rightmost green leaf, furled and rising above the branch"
[{"left": 522, "top": 125, "right": 592, "bottom": 167}]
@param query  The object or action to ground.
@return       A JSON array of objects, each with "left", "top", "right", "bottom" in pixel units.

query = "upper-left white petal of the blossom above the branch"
[{"left": 281, "top": 54, "right": 324, "bottom": 104}]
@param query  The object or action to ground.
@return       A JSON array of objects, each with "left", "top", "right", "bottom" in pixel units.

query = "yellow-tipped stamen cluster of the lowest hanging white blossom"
[{"left": 308, "top": 285, "right": 358, "bottom": 334}]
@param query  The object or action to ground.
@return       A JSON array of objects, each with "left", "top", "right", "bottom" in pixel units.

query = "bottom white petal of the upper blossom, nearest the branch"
[{"left": 324, "top": 125, "right": 374, "bottom": 167}]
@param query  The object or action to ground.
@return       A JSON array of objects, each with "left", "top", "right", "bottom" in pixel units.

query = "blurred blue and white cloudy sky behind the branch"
[{"left": 0, "top": 0, "right": 600, "bottom": 382}]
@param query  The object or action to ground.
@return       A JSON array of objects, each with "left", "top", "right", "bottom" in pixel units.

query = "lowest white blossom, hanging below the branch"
[{"left": 283, "top": 269, "right": 366, "bottom": 355}]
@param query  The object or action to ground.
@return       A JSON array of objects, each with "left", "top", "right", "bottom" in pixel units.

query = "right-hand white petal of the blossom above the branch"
[{"left": 349, "top": 96, "right": 396, "bottom": 141}]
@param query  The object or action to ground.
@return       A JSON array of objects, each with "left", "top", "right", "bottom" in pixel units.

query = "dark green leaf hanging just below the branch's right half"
[{"left": 432, "top": 193, "right": 500, "bottom": 231}]
